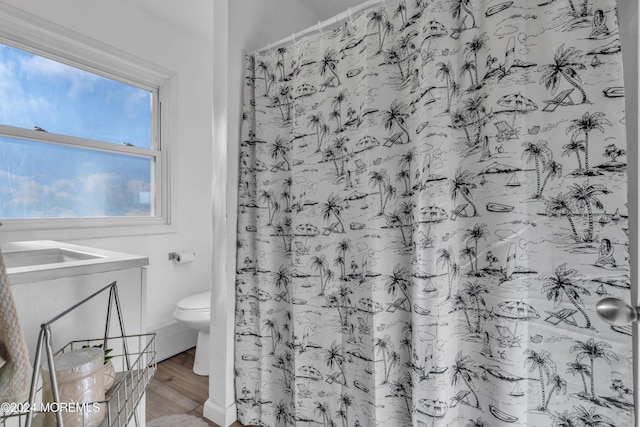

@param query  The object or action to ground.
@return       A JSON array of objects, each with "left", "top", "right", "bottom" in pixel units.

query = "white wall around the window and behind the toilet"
[{"left": 0, "top": 0, "right": 213, "bottom": 358}]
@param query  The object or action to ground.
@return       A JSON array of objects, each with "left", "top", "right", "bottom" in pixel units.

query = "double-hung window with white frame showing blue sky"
[{"left": 0, "top": 11, "right": 172, "bottom": 237}]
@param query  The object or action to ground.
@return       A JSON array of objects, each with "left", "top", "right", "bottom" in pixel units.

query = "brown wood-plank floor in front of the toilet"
[{"left": 146, "top": 348, "right": 242, "bottom": 427}]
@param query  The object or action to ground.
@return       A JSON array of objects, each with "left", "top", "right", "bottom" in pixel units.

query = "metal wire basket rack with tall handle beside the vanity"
[{"left": 0, "top": 282, "right": 157, "bottom": 427}]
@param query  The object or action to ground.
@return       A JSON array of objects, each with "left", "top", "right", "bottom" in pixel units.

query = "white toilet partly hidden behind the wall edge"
[{"left": 173, "top": 291, "right": 211, "bottom": 375}]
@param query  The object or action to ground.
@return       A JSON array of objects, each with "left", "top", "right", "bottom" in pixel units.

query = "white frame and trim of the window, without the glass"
[{"left": 0, "top": 3, "right": 177, "bottom": 240}]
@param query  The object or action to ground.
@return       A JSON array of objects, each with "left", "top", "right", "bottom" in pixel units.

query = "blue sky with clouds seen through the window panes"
[{"left": 0, "top": 45, "right": 151, "bottom": 218}]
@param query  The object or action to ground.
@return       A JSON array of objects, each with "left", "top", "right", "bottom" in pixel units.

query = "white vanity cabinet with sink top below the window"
[{"left": 0, "top": 241, "right": 150, "bottom": 426}]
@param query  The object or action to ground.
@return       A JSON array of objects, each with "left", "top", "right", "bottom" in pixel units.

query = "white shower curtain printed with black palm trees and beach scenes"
[{"left": 235, "top": 0, "right": 634, "bottom": 427}]
